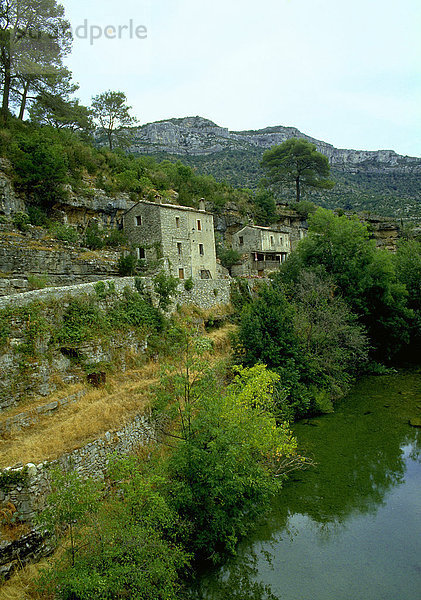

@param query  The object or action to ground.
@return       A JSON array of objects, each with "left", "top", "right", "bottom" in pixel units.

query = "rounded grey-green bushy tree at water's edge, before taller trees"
[{"left": 239, "top": 271, "right": 367, "bottom": 418}]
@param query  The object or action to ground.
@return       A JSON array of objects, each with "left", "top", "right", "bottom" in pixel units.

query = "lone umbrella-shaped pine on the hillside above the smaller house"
[{"left": 261, "top": 138, "right": 334, "bottom": 202}]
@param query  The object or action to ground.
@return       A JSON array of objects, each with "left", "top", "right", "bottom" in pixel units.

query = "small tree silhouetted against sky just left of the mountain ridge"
[{"left": 92, "top": 91, "right": 136, "bottom": 150}]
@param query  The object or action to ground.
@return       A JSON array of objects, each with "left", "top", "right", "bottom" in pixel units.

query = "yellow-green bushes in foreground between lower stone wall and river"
[{"left": 38, "top": 356, "right": 305, "bottom": 600}]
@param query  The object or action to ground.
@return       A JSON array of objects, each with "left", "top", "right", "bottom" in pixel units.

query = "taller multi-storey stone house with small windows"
[{"left": 123, "top": 200, "right": 217, "bottom": 279}]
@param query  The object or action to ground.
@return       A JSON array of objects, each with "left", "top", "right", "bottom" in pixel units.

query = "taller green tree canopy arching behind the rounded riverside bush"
[{"left": 282, "top": 208, "right": 413, "bottom": 360}]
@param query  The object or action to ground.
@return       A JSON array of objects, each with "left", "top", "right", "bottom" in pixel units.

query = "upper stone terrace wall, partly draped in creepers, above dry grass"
[{"left": 0, "top": 277, "right": 230, "bottom": 410}]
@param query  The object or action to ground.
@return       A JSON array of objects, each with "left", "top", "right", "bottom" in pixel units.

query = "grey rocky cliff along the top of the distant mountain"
[{"left": 126, "top": 117, "right": 421, "bottom": 172}]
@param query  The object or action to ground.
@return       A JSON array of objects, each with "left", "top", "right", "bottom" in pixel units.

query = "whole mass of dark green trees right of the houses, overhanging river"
[{"left": 237, "top": 208, "right": 421, "bottom": 416}]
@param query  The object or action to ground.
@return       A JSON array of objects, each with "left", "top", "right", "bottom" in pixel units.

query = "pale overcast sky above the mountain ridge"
[{"left": 62, "top": 0, "right": 421, "bottom": 156}]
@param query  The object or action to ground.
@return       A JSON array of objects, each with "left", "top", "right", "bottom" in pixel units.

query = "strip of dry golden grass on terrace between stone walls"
[{"left": 0, "top": 362, "right": 158, "bottom": 467}]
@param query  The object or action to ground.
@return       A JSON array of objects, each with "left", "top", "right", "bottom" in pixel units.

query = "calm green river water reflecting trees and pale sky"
[{"left": 192, "top": 373, "right": 421, "bottom": 600}]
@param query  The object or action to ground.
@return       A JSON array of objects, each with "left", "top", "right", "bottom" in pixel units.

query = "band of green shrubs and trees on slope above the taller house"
[{"left": 0, "top": 119, "right": 276, "bottom": 225}]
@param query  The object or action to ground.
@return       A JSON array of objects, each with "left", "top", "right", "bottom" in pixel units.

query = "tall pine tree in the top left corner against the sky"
[{"left": 0, "top": 0, "right": 72, "bottom": 125}]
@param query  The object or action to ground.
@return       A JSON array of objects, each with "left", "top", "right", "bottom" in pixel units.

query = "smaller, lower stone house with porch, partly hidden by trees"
[{"left": 231, "top": 225, "right": 291, "bottom": 277}]
